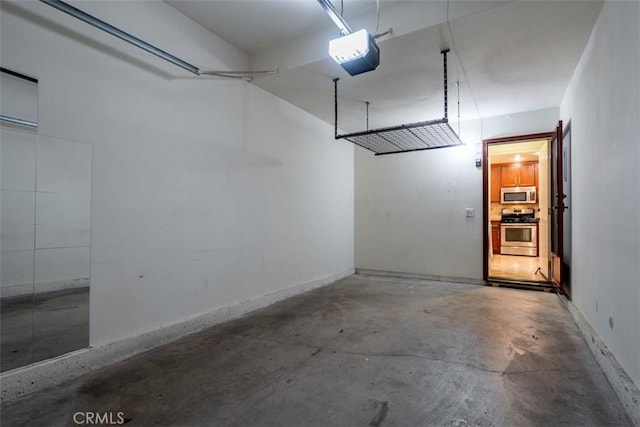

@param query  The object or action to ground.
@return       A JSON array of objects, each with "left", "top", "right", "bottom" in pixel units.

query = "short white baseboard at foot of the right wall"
[{"left": 560, "top": 295, "right": 640, "bottom": 427}]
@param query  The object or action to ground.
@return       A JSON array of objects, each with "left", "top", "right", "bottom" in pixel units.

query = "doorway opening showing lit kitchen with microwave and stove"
[{"left": 484, "top": 133, "right": 552, "bottom": 288}]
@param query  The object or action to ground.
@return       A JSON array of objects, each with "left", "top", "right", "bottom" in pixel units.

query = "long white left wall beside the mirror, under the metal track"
[{"left": 1, "top": 2, "right": 353, "bottom": 345}]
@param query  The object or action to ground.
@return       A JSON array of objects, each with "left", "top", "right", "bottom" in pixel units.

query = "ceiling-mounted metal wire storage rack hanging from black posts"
[{"left": 333, "top": 49, "right": 463, "bottom": 155}]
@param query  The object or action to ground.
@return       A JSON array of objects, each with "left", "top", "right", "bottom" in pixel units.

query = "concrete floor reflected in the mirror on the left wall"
[{"left": 0, "top": 287, "right": 89, "bottom": 372}]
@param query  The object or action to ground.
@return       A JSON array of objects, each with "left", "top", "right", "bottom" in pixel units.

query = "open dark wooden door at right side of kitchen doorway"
[{"left": 551, "top": 120, "right": 567, "bottom": 292}]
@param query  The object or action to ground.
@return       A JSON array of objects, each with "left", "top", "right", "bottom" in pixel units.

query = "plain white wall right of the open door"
[{"left": 560, "top": 1, "right": 640, "bottom": 385}]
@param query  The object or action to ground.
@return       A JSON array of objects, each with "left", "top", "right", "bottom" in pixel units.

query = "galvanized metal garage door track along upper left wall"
[{"left": 40, "top": 0, "right": 278, "bottom": 79}]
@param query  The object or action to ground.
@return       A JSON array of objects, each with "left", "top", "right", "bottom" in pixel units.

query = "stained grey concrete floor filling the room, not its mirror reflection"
[{"left": 1, "top": 276, "right": 632, "bottom": 426}]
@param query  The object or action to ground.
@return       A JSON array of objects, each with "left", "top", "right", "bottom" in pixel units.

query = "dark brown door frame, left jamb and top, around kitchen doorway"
[{"left": 482, "top": 131, "right": 555, "bottom": 282}]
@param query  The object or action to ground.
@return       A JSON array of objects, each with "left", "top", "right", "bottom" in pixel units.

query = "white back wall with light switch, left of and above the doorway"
[{"left": 355, "top": 108, "right": 558, "bottom": 280}]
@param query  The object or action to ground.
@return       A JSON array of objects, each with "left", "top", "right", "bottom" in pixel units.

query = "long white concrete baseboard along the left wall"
[{"left": 0, "top": 269, "right": 355, "bottom": 402}]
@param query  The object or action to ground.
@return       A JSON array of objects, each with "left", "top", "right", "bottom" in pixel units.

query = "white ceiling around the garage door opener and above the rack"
[{"left": 166, "top": 0, "right": 602, "bottom": 132}]
